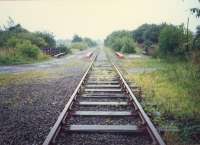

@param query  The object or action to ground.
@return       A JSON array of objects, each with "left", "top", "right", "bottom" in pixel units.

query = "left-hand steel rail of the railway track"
[{"left": 43, "top": 55, "right": 97, "bottom": 145}]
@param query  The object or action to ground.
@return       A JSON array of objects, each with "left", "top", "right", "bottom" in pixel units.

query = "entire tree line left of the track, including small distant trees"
[{"left": 0, "top": 17, "right": 96, "bottom": 64}]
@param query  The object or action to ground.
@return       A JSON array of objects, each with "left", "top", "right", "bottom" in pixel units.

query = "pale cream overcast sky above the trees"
[{"left": 0, "top": 0, "right": 200, "bottom": 39}]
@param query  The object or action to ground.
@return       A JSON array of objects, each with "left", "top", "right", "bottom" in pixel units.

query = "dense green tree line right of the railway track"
[{"left": 104, "top": 23, "right": 200, "bottom": 61}]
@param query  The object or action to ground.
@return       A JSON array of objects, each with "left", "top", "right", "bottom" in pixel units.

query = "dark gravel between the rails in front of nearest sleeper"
[{"left": 57, "top": 133, "right": 151, "bottom": 145}]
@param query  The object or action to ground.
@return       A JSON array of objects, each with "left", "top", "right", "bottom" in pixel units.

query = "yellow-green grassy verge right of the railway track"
[{"left": 122, "top": 58, "right": 200, "bottom": 143}]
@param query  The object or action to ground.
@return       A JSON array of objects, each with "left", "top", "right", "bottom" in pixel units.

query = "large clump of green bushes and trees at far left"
[{"left": 0, "top": 18, "right": 55, "bottom": 64}]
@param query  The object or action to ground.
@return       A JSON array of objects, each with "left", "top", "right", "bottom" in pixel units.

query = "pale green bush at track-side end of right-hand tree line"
[{"left": 104, "top": 31, "right": 135, "bottom": 53}]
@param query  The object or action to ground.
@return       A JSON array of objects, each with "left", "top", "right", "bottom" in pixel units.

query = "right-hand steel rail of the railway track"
[{"left": 111, "top": 62, "right": 165, "bottom": 145}]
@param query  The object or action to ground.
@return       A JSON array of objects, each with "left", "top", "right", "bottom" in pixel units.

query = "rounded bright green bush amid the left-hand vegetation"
[{"left": 16, "top": 40, "right": 40, "bottom": 59}]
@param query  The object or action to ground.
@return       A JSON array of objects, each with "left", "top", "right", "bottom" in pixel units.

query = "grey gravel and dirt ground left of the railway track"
[{"left": 0, "top": 49, "right": 90, "bottom": 145}]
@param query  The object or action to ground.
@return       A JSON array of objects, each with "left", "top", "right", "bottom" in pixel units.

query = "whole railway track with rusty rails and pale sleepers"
[{"left": 43, "top": 51, "right": 165, "bottom": 145}]
